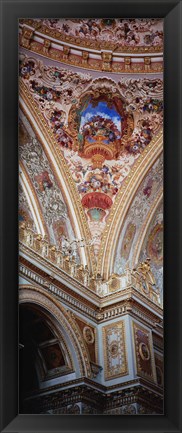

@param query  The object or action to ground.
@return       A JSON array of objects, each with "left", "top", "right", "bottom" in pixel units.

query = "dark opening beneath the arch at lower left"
[{"left": 19, "top": 304, "right": 66, "bottom": 413}]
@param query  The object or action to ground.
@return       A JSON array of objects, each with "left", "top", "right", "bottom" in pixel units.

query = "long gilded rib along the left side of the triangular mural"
[{"left": 19, "top": 80, "right": 94, "bottom": 271}]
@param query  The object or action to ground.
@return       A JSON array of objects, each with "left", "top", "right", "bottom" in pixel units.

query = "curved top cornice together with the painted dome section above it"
[{"left": 20, "top": 18, "right": 163, "bottom": 73}]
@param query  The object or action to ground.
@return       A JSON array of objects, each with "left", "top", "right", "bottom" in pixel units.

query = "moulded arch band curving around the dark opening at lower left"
[{"left": 19, "top": 285, "right": 91, "bottom": 377}]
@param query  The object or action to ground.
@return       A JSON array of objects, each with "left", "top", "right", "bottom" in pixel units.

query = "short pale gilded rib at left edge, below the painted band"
[{"left": 19, "top": 161, "right": 49, "bottom": 238}]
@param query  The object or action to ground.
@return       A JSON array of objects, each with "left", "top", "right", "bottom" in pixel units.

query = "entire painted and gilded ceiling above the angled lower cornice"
[{"left": 19, "top": 19, "right": 163, "bottom": 292}]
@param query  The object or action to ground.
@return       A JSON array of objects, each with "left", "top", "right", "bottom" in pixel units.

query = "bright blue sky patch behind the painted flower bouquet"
[{"left": 80, "top": 101, "right": 121, "bottom": 131}]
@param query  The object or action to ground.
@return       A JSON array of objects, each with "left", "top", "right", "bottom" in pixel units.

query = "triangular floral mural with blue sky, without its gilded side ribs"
[{"left": 20, "top": 54, "right": 163, "bottom": 255}]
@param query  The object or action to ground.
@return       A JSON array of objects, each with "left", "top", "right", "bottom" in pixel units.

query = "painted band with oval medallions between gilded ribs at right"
[{"left": 114, "top": 155, "right": 163, "bottom": 274}]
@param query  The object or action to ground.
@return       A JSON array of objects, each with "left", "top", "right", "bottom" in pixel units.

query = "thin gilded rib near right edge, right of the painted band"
[{"left": 132, "top": 190, "right": 163, "bottom": 267}]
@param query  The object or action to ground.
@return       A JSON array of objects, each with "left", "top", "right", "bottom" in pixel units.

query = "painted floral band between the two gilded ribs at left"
[{"left": 19, "top": 111, "right": 79, "bottom": 261}]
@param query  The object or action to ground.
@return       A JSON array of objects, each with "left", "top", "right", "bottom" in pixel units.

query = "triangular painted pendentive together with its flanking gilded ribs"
[{"left": 20, "top": 50, "right": 162, "bottom": 277}]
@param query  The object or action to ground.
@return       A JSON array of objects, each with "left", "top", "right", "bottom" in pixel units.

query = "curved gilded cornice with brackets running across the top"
[{"left": 19, "top": 20, "right": 163, "bottom": 74}]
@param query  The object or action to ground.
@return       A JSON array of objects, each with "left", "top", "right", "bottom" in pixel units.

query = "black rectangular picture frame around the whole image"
[{"left": 0, "top": 0, "right": 182, "bottom": 433}]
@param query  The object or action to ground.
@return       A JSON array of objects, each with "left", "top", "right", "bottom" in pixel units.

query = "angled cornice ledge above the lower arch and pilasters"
[{"left": 20, "top": 247, "right": 163, "bottom": 328}]
